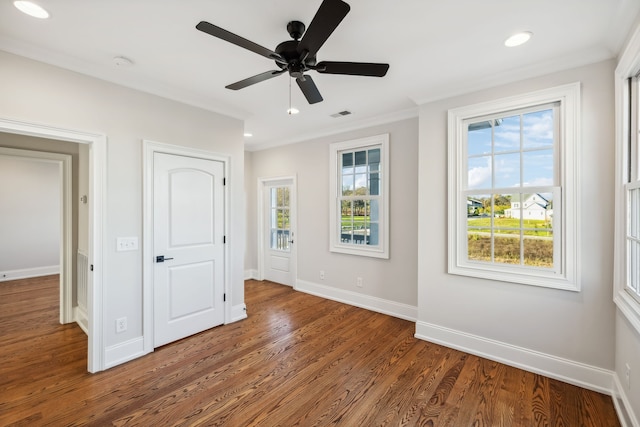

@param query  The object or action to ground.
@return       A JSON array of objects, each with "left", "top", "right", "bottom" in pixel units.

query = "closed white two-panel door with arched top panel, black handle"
[{"left": 153, "top": 153, "right": 225, "bottom": 347}]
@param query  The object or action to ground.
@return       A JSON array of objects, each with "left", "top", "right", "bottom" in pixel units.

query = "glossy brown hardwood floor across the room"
[{"left": 0, "top": 276, "right": 619, "bottom": 427}]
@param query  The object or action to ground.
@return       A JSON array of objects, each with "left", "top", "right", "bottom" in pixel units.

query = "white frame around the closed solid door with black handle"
[{"left": 142, "top": 140, "right": 232, "bottom": 354}]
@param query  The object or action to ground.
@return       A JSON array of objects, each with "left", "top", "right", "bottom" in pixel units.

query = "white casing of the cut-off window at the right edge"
[{"left": 613, "top": 26, "right": 640, "bottom": 333}]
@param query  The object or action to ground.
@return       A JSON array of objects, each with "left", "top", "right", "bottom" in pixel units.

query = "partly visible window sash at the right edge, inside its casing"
[{"left": 625, "top": 76, "right": 640, "bottom": 302}]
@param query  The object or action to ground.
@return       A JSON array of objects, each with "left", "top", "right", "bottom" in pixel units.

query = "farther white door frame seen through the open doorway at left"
[{"left": 0, "top": 147, "right": 74, "bottom": 324}]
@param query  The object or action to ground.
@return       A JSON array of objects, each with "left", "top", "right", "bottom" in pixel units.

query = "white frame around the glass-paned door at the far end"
[{"left": 257, "top": 175, "right": 298, "bottom": 289}]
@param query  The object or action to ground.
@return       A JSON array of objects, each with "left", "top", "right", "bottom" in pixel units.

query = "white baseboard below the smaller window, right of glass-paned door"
[{"left": 294, "top": 280, "right": 418, "bottom": 322}]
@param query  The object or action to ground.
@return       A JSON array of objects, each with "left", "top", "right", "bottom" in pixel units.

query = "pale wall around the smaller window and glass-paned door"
[{"left": 246, "top": 118, "right": 418, "bottom": 319}]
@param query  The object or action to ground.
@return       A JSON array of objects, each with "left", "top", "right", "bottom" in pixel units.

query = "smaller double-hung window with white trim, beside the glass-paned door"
[{"left": 329, "top": 134, "right": 389, "bottom": 258}]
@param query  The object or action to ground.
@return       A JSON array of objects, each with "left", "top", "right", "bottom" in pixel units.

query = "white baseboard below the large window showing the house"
[{"left": 415, "top": 322, "right": 614, "bottom": 395}]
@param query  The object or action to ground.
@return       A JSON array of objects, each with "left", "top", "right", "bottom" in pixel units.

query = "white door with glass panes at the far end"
[{"left": 263, "top": 179, "right": 295, "bottom": 286}]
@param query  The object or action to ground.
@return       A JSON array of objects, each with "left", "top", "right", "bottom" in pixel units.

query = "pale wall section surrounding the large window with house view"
[{"left": 416, "top": 61, "right": 615, "bottom": 390}]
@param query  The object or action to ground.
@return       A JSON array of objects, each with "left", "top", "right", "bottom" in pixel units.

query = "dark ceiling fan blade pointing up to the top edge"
[{"left": 298, "top": 0, "right": 351, "bottom": 57}]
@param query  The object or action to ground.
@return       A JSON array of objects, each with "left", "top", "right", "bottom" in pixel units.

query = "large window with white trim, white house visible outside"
[{"left": 448, "top": 83, "right": 580, "bottom": 290}]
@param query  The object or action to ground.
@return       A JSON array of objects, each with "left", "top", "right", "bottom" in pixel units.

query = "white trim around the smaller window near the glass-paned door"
[{"left": 329, "top": 134, "right": 389, "bottom": 259}]
